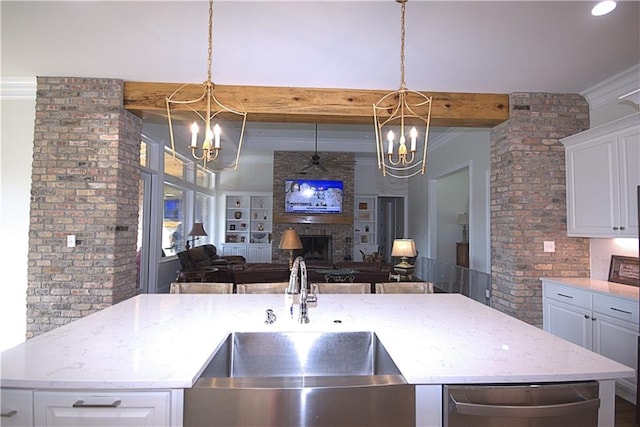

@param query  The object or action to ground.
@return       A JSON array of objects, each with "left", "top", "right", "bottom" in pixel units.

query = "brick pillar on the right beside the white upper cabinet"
[{"left": 491, "top": 93, "right": 589, "bottom": 326}]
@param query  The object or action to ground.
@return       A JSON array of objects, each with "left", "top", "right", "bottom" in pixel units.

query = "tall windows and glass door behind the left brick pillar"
[{"left": 138, "top": 130, "right": 216, "bottom": 293}]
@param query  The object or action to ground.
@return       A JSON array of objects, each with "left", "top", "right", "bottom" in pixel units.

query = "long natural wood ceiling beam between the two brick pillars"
[{"left": 124, "top": 82, "right": 509, "bottom": 128}]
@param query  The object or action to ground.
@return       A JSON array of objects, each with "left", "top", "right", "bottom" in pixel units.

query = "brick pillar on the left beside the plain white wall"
[{"left": 27, "top": 77, "right": 142, "bottom": 338}]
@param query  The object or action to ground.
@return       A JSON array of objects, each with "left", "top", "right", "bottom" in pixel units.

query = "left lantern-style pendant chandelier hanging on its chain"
[{"left": 166, "top": 0, "right": 247, "bottom": 172}]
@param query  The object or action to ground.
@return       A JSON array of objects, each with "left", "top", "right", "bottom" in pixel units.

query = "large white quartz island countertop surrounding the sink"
[{"left": 1, "top": 294, "right": 634, "bottom": 389}]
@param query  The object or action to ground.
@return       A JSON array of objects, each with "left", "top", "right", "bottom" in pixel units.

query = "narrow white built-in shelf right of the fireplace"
[{"left": 353, "top": 196, "right": 378, "bottom": 261}]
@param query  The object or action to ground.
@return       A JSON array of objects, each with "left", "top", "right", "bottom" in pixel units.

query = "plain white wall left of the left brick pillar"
[{"left": 0, "top": 78, "right": 35, "bottom": 350}]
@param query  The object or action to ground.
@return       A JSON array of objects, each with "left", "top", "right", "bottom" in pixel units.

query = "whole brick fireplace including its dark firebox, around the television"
[{"left": 271, "top": 151, "right": 355, "bottom": 263}]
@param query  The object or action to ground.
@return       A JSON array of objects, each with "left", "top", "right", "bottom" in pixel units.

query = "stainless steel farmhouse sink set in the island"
[{"left": 184, "top": 332, "right": 415, "bottom": 426}]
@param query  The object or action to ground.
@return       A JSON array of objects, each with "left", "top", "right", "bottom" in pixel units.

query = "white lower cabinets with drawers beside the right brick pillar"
[{"left": 542, "top": 280, "right": 639, "bottom": 402}]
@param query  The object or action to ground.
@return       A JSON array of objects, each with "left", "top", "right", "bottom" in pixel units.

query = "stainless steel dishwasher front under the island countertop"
[{"left": 443, "top": 381, "right": 600, "bottom": 427}]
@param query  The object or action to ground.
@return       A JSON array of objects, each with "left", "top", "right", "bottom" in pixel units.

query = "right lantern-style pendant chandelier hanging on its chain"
[{"left": 373, "top": 0, "right": 431, "bottom": 178}]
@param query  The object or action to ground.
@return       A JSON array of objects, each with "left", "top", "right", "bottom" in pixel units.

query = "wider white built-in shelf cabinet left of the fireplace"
[{"left": 222, "top": 193, "right": 273, "bottom": 262}]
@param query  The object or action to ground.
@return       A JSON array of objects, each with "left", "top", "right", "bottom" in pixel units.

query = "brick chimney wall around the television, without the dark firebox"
[{"left": 272, "top": 151, "right": 355, "bottom": 263}]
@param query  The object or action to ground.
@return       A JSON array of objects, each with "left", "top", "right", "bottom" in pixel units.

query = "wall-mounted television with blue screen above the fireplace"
[{"left": 284, "top": 179, "right": 343, "bottom": 214}]
